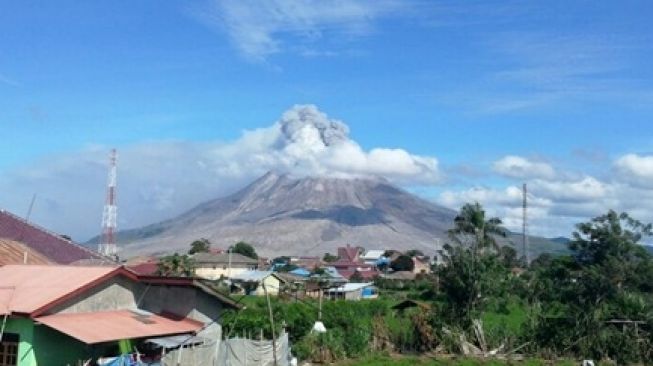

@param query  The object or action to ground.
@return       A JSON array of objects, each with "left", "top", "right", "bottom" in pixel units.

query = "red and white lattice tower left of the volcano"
[{"left": 98, "top": 149, "right": 118, "bottom": 256}]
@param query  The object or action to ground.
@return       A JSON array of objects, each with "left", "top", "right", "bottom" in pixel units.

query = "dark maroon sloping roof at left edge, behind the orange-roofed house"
[{"left": 0, "top": 210, "right": 103, "bottom": 264}]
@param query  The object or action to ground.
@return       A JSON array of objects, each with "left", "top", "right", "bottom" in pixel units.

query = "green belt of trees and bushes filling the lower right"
[{"left": 224, "top": 204, "right": 653, "bottom": 366}]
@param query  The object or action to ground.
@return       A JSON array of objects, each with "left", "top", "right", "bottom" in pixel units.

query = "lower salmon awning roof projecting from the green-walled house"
[{"left": 35, "top": 310, "right": 204, "bottom": 344}]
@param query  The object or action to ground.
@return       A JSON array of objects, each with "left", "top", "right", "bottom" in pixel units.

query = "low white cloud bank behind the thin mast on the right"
[{"left": 437, "top": 168, "right": 653, "bottom": 236}]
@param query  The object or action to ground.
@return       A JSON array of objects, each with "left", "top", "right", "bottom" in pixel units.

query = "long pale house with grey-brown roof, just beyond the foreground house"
[{"left": 193, "top": 253, "right": 259, "bottom": 280}]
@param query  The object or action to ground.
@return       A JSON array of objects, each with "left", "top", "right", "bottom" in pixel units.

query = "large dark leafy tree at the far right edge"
[{"left": 534, "top": 210, "right": 653, "bottom": 364}]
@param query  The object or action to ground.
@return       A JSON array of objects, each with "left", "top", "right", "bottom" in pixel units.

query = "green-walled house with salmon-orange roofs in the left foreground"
[{"left": 0, "top": 265, "right": 239, "bottom": 366}]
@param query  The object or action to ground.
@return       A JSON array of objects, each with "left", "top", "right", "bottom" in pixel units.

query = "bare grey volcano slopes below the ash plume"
[{"left": 107, "top": 173, "right": 564, "bottom": 256}]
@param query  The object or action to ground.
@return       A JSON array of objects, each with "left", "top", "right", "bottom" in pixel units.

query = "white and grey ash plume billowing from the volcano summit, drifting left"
[{"left": 0, "top": 105, "right": 441, "bottom": 240}]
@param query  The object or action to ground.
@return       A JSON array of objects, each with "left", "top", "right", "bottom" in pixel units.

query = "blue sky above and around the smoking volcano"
[{"left": 0, "top": 0, "right": 653, "bottom": 239}]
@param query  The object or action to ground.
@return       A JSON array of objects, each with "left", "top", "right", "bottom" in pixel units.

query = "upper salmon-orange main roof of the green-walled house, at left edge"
[{"left": 0, "top": 265, "right": 117, "bottom": 314}]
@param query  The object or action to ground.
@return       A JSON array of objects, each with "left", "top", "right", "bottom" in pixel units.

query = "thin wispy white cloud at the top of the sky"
[{"left": 198, "top": 0, "right": 402, "bottom": 60}]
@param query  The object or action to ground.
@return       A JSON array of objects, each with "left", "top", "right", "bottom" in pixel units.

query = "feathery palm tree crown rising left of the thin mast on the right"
[{"left": 449, "top": 202, "right": 507, "bottom": 252}]
